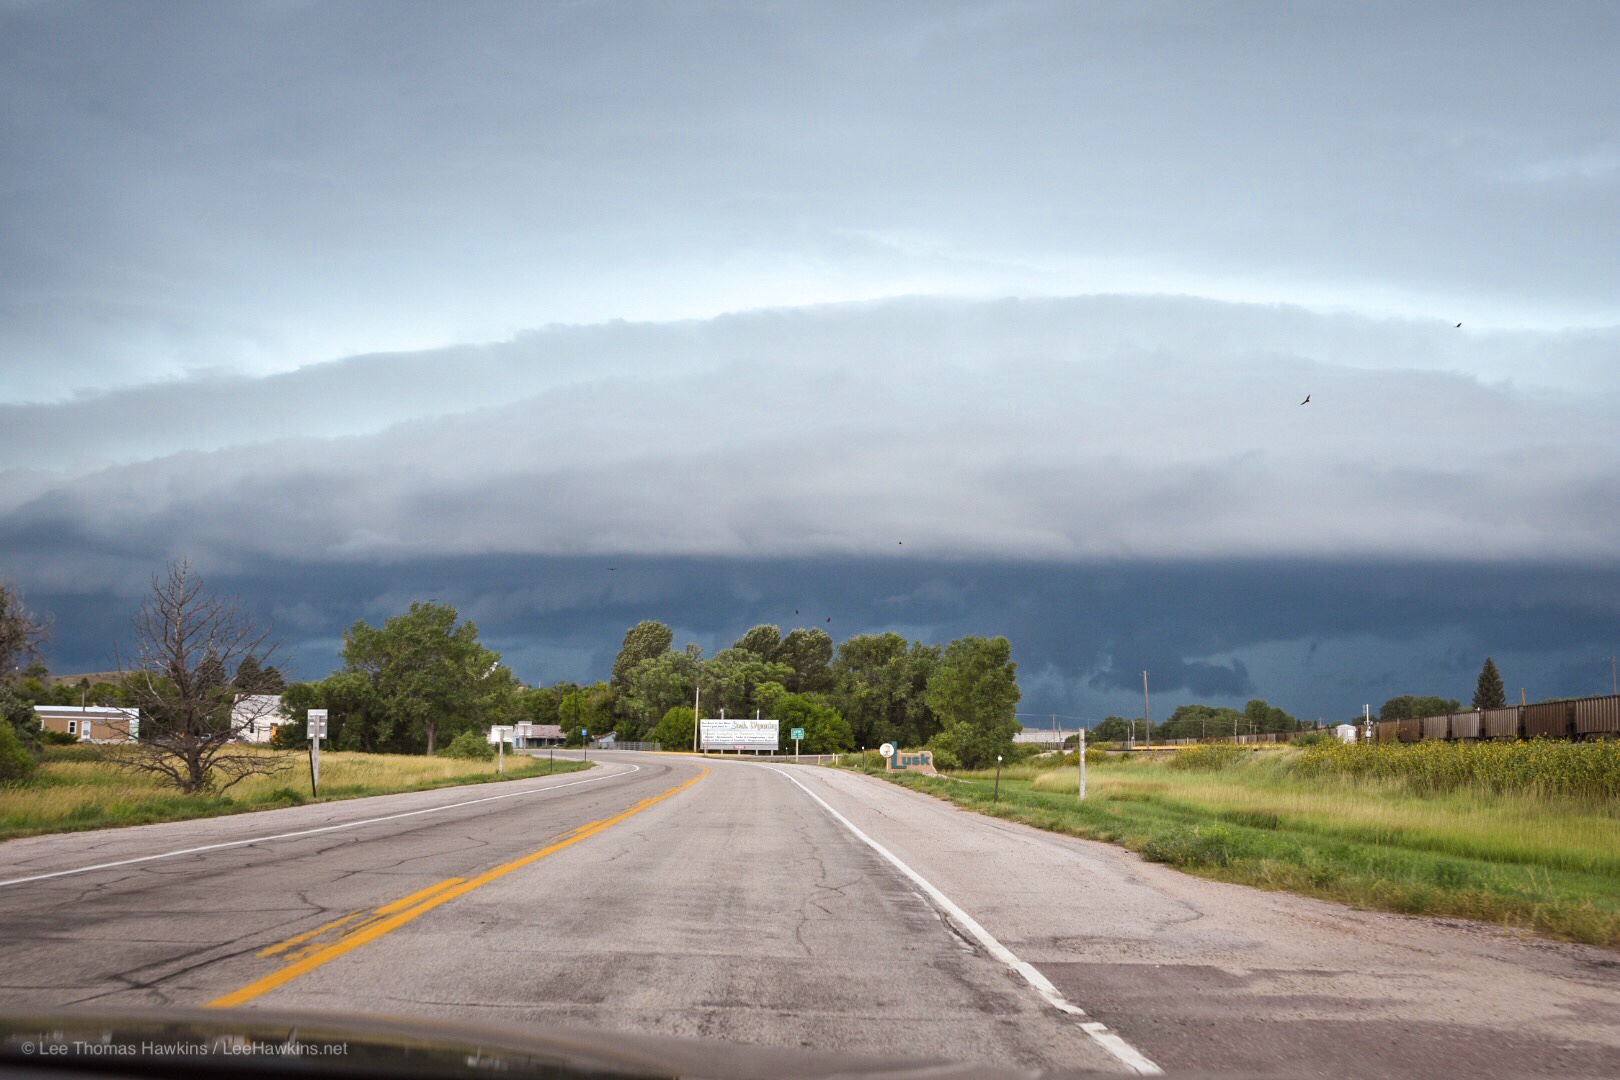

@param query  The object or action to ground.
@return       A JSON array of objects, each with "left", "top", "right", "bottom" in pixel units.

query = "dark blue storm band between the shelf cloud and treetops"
[{"left": 29, "top": 555, "right": 1620, "bottom": 719}]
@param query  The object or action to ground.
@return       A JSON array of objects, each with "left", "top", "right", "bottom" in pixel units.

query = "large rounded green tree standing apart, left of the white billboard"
[{"left": 343, "top": 602, "right": 517, "bottom": 755}]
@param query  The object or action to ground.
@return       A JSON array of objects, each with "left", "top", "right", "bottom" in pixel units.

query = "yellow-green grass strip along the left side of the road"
[{"left": 0, "top": 746, "right": 590, "bottom": 840}]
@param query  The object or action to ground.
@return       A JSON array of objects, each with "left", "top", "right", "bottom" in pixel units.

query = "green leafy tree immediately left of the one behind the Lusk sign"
[{"left": 828, "top": 633, "right": 940, "bottom": 746}]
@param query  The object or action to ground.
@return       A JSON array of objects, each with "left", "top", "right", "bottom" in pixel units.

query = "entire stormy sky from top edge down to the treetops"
[{"left": 0, "top": 0, "right": 1620, "bottom": 722}]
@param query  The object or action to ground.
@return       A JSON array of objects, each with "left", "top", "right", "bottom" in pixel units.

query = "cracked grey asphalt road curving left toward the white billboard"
[{"left": 0, "top": 753, "right": 1620, "bottom": 1078}]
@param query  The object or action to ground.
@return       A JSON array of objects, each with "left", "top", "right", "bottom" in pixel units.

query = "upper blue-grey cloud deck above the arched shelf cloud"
[{"left": 0, "top": 2, "right": 1620, "bottom": 402}]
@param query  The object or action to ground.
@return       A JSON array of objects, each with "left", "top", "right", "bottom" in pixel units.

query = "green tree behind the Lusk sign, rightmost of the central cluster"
[{"left": 925, "top": 636, "right": 1024, "bottom": 769}]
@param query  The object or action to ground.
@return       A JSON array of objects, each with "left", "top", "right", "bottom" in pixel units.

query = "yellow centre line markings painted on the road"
[{"left": 207, "top": 769, "right": 710, "bottom": 1009}]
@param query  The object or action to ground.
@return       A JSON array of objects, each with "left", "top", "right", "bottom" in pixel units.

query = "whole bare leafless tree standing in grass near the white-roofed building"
[{"left": 112, "top": 562, "right": 292, "bottom": 793}]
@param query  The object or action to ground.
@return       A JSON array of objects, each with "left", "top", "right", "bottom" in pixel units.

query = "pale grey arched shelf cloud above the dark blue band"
[{"left": 0, "top": 298, "right": 1620, "bottom": 576}]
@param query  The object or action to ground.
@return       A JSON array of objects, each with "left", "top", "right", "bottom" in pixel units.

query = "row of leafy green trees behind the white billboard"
[{"left": 279, "top": 615, "right": 1019, "bottom": 764}]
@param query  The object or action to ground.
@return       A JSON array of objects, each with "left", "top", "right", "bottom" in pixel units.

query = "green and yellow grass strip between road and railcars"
[{"left": 861, "top": 751, "right": 1620, "bottom": 947}]
